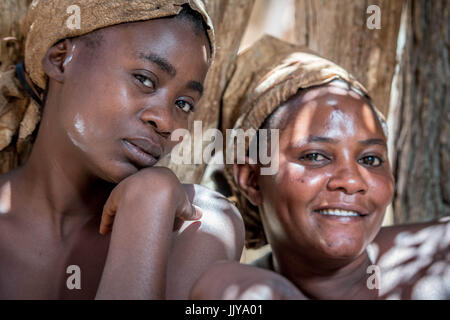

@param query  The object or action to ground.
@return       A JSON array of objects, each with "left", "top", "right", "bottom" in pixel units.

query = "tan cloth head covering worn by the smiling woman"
[{"left": 222, "top": 36, "right": 386, "bottom": 247}]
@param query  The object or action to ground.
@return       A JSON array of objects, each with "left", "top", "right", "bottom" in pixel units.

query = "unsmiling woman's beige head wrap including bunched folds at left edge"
[{"left": 0, "top": 0, "right": 215, "bottom": 173}]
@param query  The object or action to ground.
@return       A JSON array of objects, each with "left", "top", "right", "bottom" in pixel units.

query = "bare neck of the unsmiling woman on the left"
[{"left": 7, "top": 126, "right": 114, "bottom": 238}]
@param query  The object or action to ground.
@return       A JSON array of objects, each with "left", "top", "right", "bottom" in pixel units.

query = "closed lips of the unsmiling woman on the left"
[{"left": 122, "top": 138, "right": 162, "bottom": 168}]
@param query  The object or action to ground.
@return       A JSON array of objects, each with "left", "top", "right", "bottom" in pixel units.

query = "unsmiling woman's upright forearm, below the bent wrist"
[{"left": 96, "top": 190, "right": 176, "bottom": 299}]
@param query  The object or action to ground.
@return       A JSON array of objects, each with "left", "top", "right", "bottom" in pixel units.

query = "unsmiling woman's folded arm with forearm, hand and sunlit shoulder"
[{"left": 97, "top": 168, "right": 244, "bottom": 299}]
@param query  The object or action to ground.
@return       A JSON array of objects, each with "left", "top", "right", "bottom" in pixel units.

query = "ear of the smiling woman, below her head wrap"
[{"left": 233, "top": 157, "right": 261, "bottom": 206}]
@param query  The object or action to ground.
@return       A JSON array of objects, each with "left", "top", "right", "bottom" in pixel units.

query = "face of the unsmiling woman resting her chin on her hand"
[{"left": 50, "top": 18, "right": 209, "bottom": 182}]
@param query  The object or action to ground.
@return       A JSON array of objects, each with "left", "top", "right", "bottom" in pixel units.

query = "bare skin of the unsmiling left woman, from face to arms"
[{"left": 0, "top": 18, "right": 243, "bottom": 299}]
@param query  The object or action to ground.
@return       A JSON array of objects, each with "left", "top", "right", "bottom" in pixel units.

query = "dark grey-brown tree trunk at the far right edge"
[{"left": 393, "top": 0, "right": 450, "bottom": 223}]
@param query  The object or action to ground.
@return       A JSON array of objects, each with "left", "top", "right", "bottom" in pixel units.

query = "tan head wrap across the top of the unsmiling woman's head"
[{"left": 25, "top": 0, "right": 214, "bottom": 88}]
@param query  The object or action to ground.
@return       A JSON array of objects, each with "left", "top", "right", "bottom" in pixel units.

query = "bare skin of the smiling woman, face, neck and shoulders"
[{"left": 193, "top": 83, "right": 450, "bottom": 299}]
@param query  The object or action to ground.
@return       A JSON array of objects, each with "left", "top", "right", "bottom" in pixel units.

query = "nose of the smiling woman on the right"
[{"left": 328, "top": 164, "right": 368, "bottom": 195}]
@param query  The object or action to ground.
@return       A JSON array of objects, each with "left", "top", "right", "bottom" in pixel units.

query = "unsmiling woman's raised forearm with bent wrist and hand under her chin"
[{"left": 96, "top": 168, "right": 197, "bottom": 299}]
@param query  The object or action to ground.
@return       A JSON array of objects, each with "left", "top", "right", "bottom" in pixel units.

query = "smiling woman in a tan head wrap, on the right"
[{"left": 192, "top": 37, "right": 450, "bottom": 299}]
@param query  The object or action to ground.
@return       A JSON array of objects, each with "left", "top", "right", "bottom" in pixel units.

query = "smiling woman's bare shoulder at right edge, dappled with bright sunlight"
[{"left": 369, "top": 218, "right": 450, "bottom": 299}]
